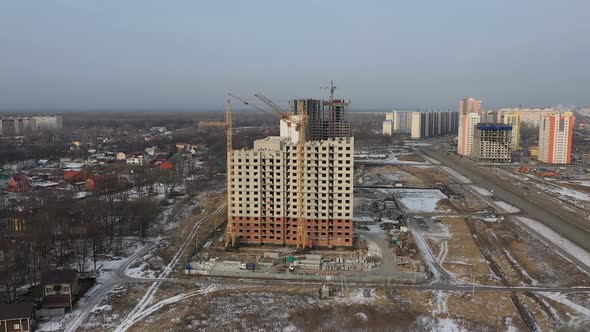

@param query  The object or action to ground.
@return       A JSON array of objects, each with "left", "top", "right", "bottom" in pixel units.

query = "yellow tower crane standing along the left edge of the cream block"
[{"left": 199, "top": 99, "right": 236, "bottom": 247}]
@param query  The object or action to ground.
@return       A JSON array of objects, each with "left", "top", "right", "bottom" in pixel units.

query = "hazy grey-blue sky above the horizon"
[{"left": 0, "top": 0, "right": 590, "bottom": 110}]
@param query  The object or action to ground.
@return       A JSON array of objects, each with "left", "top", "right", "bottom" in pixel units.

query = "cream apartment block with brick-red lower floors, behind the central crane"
[{"left": 229, "top": 136, "right": 354, "bottom": 246}]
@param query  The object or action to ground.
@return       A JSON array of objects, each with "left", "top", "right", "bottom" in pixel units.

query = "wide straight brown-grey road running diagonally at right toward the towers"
[{"left": 418, "top": 147, "right": 590, "bottom": 251}]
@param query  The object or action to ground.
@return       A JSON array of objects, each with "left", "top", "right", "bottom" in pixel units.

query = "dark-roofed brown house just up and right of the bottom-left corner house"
[{"left": 39, "top": 270, "right": 79, "bottom": 316}]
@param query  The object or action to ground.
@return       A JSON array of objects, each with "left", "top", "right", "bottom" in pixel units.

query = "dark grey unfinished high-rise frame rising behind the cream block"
[{"left": 291, "top": 98, "right": 351, "bottom": 141}]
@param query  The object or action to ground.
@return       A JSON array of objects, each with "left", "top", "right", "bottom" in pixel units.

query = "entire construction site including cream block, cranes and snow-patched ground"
[{"left": 32, "top": 89, "right": 590, "bottom": 331}]
